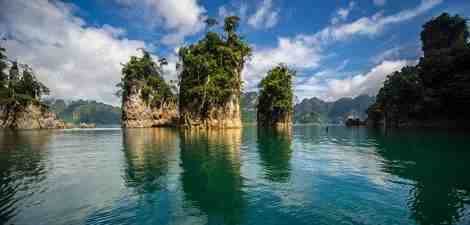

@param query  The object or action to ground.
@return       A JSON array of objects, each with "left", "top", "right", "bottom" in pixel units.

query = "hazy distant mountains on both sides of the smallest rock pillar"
[{"left": 240, "top": 92, "right": 375, "bottom": 123}]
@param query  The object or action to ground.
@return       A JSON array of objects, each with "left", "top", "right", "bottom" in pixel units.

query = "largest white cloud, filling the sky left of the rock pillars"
[{"left": 0, "top": 0, "right": 146, "bottom": 104}]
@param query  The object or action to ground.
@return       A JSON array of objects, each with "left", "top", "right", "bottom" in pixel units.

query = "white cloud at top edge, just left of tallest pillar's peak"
[{"left": 115, "top": 0, "right": 206, "bottom": 45}]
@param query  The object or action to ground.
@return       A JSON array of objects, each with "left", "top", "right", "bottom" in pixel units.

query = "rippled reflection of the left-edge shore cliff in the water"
[{"left": 0, "top": 131, "right": 51, "bottom": 224}]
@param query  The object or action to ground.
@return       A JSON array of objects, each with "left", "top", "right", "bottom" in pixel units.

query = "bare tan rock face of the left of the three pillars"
[{"left": 122, "top": 85, "right": 178, "bottom": 128}]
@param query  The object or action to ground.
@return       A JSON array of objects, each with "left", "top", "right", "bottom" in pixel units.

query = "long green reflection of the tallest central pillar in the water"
[{"left": 181, "top": 129, "right": 244, "bottom": 224}]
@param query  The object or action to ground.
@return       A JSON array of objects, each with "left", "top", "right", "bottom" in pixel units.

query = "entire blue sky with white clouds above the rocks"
[{"left": 0, "top": 0, "right": 470, "bottom": 104}]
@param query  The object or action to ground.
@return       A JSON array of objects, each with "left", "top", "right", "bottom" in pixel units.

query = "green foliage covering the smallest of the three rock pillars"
[{"left": 257, "top": 64, "right": 295, "bottom": 124}]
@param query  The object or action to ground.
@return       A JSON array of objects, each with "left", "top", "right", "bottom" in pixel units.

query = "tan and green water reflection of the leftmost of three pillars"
[{"left": 123, "top": 128, "right": 177, "bottom": 193}]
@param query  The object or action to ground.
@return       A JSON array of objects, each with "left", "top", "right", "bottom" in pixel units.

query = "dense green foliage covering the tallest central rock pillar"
[{"left": 179, "top": 16, "right": 251, "bottom": 117}]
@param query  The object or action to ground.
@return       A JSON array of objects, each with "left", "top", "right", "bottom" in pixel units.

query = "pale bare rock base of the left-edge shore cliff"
[{"left": 0, "top": 104, "right": 65, "bottom": 129}]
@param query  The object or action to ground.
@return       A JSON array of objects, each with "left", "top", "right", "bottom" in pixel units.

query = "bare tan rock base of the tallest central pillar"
[{"left": 180, "top": 94, "right": 242, "bottom": 129}]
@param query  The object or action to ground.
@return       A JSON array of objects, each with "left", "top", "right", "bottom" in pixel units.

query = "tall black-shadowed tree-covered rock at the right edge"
[{"left": 418, "top": 13, "right": 470, "bottom": 117}]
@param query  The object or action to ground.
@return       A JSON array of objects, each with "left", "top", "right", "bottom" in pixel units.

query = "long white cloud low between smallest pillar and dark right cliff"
[{"left": 296, "top": 60, "right": 415, "bottom": 101}]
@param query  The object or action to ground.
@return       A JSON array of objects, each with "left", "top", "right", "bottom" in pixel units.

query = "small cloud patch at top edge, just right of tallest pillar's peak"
[{"left": 248, "top": 0, "right": 279, "bottom": 28}]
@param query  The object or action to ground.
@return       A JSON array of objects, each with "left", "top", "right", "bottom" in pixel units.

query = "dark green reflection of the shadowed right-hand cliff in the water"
[{"left": 370, "top": 130, "right": 470, "bottom": 224}]
